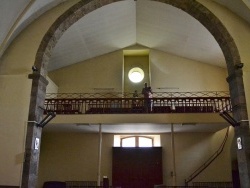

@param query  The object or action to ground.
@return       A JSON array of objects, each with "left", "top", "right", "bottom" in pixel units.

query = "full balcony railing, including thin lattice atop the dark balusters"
[{"left": 44, "top": 92, "right": 232, "bottom": 114}]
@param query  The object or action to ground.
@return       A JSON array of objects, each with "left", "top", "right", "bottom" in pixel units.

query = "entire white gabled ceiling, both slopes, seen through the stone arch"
[{"left": 49, "top": 0, "right": 226, "bottom": 70}]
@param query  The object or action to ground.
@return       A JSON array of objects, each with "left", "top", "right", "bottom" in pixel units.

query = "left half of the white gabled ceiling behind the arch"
[{"left": 49, "top": 0, "right": 136, "bottom": 70}]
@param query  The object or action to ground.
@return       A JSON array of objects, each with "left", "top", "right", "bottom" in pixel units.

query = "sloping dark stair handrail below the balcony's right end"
[{"left": 185, "top": 127, "right": 229, "bottom": 186}]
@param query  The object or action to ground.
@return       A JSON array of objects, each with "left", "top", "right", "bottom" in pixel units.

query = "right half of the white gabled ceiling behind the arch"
[{"left": 136, "top": 1, "right": 225, "bottom": 67}]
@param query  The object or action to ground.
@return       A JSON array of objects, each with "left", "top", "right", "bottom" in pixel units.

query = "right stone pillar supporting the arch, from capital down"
[{"left": 227, "top": 68, "right": 250, "bottom": 188}]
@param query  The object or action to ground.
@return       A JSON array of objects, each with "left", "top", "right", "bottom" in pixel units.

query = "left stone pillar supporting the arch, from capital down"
[{"left": 21, "top": 72, "right": 48, "bottom": 188}]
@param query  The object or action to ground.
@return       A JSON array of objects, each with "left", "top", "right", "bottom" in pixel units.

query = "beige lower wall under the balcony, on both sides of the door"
[{"left": 39, "top": 129, "right": 233, "bottom": 187}]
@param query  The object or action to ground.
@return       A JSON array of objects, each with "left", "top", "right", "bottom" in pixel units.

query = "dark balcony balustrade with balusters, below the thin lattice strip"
[{"left": 44, "top": 97, "right": 232, "bottom": 114}]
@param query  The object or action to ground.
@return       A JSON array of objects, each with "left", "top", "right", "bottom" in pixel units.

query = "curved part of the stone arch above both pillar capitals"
[{"left": 35, "top": 0, "right": 241, "bottom": 74}]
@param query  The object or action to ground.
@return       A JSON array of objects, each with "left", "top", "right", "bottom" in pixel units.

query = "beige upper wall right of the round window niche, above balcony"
[{"left": 150, "top": 50, "right": 228, "bottom": 92}]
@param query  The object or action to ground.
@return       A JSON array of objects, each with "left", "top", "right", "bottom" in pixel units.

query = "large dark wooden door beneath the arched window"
[{"left": 112, "top": 147, "right": 162, "bottom": 188}]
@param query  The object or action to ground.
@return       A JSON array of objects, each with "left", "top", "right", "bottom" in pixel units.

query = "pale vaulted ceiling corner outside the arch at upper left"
[{"left": 0, "top": 0, "right": 64, "bottom": 57}]
